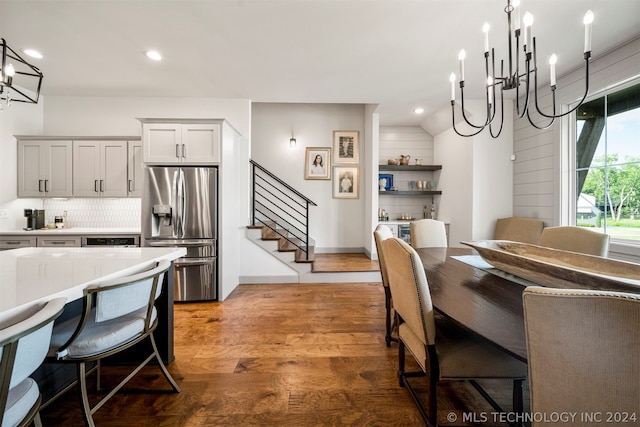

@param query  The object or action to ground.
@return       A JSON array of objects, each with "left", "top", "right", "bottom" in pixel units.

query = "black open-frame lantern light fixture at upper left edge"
[{"left": 0, "top": 39, "right": 42, "bottom": 109}]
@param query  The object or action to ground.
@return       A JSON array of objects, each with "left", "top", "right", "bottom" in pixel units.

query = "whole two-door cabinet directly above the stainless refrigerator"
[{"left": 139, "top": 119, "right": 222, "bottom": 165}]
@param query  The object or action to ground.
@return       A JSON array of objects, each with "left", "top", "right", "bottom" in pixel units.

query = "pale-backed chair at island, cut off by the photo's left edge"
[{"left": 0, "top": 298, "right": 66, "bottom": 427}]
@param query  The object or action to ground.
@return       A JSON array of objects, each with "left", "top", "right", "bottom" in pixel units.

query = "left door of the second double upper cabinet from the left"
[{"left": 73, "top": 141, "right": 100, "bottom": 197}]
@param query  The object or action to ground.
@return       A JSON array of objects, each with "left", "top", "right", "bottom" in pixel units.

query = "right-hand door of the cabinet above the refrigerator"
[{"left": 182, "top": 123, "right": 220, "bottom": 164}]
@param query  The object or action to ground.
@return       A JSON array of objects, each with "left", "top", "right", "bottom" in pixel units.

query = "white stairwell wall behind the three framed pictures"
[{"left": 251, "top": 103, "right": 370, "bottom": 253}]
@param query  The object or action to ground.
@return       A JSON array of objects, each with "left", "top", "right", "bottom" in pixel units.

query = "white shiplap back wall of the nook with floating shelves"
[{"left": 378, "top": 126, "right": 437, "bottom": 220}]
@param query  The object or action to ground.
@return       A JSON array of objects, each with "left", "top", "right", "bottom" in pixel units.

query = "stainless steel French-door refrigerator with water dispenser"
[{"left": 141, "top": 166, "right": 218, "bottom": 301}]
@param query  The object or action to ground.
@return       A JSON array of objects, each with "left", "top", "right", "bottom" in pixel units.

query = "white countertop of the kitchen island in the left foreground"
[{"left": 0, "top": 247, "right": 187, "bottom": 318}]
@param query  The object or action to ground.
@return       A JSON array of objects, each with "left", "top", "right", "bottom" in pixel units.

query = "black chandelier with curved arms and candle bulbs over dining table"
[{"left": 449, "top": 0, "right": 593, "bottom": 138}]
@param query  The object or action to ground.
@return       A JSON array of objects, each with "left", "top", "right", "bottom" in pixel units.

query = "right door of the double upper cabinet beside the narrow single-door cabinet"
[{"left": 100, "top": 141, "right": 127, "bottom": 197}]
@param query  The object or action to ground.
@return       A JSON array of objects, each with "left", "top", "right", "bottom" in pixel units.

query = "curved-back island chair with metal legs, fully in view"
[{"left": 49, "top": 260, "right": 180, "bottom": 426}]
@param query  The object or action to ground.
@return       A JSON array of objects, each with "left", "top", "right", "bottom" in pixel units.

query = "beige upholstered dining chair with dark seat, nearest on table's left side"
[{"left": 382, "top": 238, "right": 527, "bottom": 425}]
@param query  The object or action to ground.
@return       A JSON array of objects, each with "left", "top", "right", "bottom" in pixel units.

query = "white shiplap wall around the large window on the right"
[{"left": 513, "top": 36, "right": 640, "bottom": 262}]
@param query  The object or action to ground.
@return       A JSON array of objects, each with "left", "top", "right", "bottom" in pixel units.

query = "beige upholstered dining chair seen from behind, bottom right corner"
[{"left": 522, "top": 286, "right": 640, "bottom": 427}]
